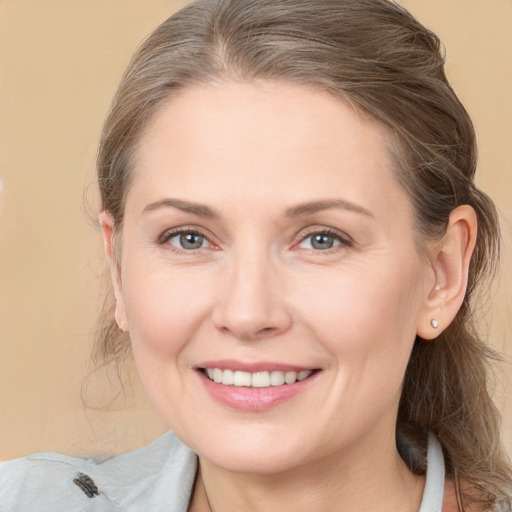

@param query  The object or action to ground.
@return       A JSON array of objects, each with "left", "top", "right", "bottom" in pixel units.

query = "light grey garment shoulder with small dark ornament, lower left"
[{"left": 0, "top": 432, "right": 197, "bottom": 512}]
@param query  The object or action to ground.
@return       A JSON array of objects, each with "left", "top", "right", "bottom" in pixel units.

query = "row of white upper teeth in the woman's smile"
[{"left": 206, "top": 368, "right": 313, "bottom": 388}]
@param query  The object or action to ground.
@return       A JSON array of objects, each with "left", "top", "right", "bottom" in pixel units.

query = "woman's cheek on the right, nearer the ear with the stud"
[{"left": 296, "top": 266, "right": 421, "bottom": 436}]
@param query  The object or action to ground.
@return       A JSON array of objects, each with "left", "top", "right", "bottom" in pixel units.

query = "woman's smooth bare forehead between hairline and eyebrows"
[{"left": 128, "top": 82, "right": 410, "bottom": 218}]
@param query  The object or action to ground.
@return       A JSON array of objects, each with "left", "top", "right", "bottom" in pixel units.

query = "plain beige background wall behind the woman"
[{"left": 0, "top": 0, "right": 512, "bottom": 459}]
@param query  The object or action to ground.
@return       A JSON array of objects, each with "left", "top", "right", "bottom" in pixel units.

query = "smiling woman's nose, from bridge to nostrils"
[{"left": 212, "top": 248, "right": 292, "bottom": 341}]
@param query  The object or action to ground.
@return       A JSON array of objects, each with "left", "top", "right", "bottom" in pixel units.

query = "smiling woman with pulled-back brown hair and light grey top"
[{"left": 0, "top": 0, "right": 512, "bottom": 512}]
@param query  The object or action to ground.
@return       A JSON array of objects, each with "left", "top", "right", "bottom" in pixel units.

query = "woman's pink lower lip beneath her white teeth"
[{"left": 197, "top": 371, "right": 320, "bottom": 412}]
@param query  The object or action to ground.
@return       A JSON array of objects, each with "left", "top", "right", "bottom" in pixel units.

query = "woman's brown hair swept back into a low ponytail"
[{"left": 96, "top": 0, "right": 512, "bottom": 511}]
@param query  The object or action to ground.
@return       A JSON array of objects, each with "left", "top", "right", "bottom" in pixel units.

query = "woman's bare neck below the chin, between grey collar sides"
[{"left": 190, "top": 432, "right": 424, "bottom": 512}]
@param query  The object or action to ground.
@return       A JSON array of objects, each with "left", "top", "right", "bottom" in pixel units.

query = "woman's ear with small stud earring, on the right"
[{"left": 416, "top": 205, "right": 477, "bottom": 340}]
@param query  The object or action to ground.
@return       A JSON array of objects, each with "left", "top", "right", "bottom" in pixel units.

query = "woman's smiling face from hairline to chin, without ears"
[{"left": 110, "top": 82, "right": 433, "bottom": 472}]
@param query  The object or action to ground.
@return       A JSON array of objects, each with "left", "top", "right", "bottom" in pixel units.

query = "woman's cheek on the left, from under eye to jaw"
[{"left": 119, "top": 267, "right": 217, "bottom": 426}]
